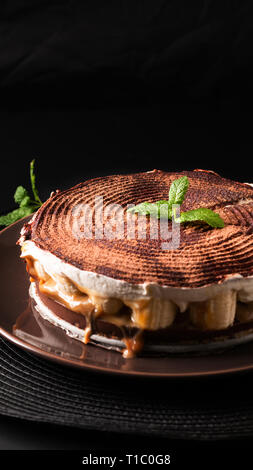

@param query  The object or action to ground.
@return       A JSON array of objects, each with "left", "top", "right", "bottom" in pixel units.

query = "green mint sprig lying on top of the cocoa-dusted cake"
[{"left": 127, "top": 176, "right": 225, "bottom": 228}]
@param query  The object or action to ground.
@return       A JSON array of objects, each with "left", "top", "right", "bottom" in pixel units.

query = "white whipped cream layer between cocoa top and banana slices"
[{"left": 21, "top": 240, "right": 253, "bottom": 312}]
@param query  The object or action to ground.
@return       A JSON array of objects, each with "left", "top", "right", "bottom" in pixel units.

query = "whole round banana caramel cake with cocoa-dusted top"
[{"left": 18, "top": 170, "right": 253, "bottom": 357}]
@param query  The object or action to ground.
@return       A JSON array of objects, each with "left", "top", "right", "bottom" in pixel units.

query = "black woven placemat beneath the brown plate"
[{"left": 0, "top": 338, "right": 253, "bottom": 440}]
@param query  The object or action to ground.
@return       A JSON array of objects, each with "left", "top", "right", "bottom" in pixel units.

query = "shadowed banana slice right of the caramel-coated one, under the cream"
[{"left": 189, "top": 290, "right": 236, "bottom": 330}]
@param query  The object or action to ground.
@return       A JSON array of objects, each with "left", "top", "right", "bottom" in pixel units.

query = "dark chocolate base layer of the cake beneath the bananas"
[{"left": 29, "top": 282, "right": 253, "bottom": 357}]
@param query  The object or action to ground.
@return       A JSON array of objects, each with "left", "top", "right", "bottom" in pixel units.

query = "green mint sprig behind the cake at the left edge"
[{"left": 0, "top": 160, "right": 42, "bottom": 227}]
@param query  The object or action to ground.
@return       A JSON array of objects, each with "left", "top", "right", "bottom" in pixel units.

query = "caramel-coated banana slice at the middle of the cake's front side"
[{"left": 124, "top": 298, "right": 177, "bottom": 330}]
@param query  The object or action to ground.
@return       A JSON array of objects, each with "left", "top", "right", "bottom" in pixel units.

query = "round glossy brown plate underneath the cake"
[{"left": 0, "top": 218, "right": 253, "bottom": 378}]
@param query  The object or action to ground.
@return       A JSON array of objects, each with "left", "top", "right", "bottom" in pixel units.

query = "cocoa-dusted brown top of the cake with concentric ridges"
[{"left": 19, "top": 170, "right": 253, "bottom": 288}]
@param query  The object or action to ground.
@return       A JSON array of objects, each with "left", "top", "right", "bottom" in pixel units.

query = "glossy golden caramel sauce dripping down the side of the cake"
[{"left": 20, "top": 256, "right": 253, "bottom": 358}]
